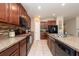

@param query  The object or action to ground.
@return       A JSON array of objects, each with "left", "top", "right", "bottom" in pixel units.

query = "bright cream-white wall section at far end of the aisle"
[{"left": 31, "top": 17, "right": 40, "bottom": 40}]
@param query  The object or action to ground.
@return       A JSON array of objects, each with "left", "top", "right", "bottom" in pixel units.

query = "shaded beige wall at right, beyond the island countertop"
[{"left": 65, "top": 19, "right": 76, "bottom": 36}]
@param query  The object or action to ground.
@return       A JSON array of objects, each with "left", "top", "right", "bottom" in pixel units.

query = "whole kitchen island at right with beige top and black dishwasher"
[{"left": 47, "top": 34, "right": 79, "bottom": 56}]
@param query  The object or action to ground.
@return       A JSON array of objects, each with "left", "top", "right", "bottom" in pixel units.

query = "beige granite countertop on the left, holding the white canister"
[{"left": 0, "top": 33, "right": 30, "bottom": 52}]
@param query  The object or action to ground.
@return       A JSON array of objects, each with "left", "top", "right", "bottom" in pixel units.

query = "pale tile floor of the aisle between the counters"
[{"left": 28, "top": 40, "right": 52, "bottom": 56}]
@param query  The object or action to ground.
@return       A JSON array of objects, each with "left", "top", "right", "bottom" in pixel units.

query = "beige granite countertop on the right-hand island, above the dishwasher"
[{"left": 48, "top": 34, "right": 79, "bottom": 52}]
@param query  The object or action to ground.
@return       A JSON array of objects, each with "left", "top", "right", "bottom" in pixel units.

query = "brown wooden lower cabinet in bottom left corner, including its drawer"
[{"left": 0, "top": 44, "right": 19, "bottom": 56}]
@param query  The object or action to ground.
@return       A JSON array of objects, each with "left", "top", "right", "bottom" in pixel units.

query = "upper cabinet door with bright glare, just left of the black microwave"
[{"left": 9, "top": 3, "right": 19, "bottom": 25}]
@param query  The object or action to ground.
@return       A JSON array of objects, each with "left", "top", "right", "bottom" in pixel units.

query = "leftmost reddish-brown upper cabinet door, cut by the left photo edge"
[{"left": 0, "top": 3, "right": 9, "bottom": 22}]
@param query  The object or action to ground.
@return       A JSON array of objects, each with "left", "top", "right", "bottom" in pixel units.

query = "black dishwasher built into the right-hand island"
[{"left": 56, "top": 40, "right": 76, "bottom": 56}]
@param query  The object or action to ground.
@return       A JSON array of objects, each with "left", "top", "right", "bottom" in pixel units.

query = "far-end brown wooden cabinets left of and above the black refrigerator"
[{"left": 40, "top": 20, "right": 56, "bottom": 39}]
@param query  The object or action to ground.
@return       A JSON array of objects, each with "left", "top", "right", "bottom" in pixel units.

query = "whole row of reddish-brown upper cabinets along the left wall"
[{"left": 0, "top": 3, "right": 31, "bottom": 26}]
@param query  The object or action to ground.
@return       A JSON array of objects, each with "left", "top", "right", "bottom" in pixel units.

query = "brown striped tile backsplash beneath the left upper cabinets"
[{"left": 0, "top": 23, "right": 25, "bottom": 36}]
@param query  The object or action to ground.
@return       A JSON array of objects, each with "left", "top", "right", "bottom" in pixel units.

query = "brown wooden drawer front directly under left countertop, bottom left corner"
[{"left": 0, "top": 44, "right": 19, "bottom": 56}]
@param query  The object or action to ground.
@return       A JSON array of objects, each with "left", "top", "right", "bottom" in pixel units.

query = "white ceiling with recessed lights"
[{"left": 22, "top": 3, "right": 79, "bottom": 18}]
